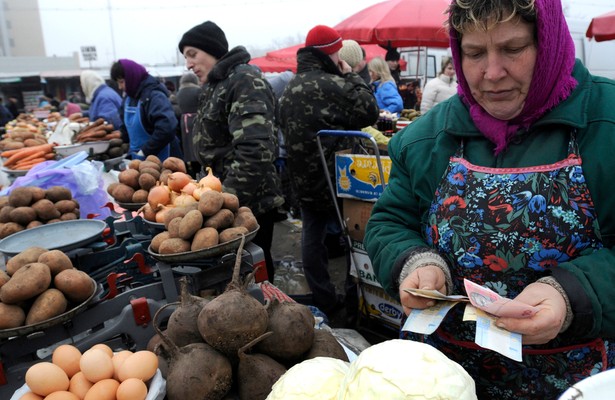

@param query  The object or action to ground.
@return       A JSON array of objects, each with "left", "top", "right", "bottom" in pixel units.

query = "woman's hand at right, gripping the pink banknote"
[{"left": 496, "top": 283, "right": 566, "bottom": 344}]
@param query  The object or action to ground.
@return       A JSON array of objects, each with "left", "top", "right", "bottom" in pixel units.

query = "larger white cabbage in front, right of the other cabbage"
[{"left": 336, "top": 339, "right": 477, "bottom": 400}]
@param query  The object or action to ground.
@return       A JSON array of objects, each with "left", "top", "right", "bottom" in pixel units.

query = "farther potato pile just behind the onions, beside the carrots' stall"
[{"left": 107, "top": 155, "right": 186, "bottom": 204}]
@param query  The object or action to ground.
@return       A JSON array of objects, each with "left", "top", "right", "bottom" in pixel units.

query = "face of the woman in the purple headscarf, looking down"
[{"left": 461, "top": 21, "right": 536, "bottom": 120}]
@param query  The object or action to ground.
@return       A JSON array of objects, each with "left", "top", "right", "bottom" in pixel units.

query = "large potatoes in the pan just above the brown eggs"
[{"left": 0, "top": 246, "right": 96, "bottom": 329}]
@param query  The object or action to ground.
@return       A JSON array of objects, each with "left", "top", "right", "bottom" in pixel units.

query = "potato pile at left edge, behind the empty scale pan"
[{"left": 0, "top": 186, "right": 80, "bottom": 239}]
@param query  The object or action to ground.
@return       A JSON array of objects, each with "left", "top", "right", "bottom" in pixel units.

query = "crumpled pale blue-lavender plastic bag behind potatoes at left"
[{"left": 0, "top": 151, "right": 111, "bottom": 220}]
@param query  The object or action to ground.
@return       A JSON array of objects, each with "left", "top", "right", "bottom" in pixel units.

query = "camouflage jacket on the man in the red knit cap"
[{"left": 277, "top": 47, "right": 379, "bottom": 209}]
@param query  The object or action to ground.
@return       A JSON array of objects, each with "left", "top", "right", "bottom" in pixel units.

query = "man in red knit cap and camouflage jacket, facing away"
[{"left": 278, "top": 25, "right": 379, "bottom": 313}]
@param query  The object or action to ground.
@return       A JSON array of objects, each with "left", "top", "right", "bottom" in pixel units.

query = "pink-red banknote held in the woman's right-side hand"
[{"left": 463, "top": 279, "right": 538, "bottom": 318}]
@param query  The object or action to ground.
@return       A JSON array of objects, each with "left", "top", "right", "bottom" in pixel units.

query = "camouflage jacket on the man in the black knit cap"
[{"left": 193, "top": 46, "right": 284, "bottom": 216}]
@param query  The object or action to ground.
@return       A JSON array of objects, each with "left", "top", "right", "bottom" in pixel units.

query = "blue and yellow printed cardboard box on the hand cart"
[{"left": 335, "top": 150, "right": 391, "bottom": 202}]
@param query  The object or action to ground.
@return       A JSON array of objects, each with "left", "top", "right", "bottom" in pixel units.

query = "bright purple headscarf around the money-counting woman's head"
[{"left": 449, "top": 0, "right": 577, "bottom": 155}]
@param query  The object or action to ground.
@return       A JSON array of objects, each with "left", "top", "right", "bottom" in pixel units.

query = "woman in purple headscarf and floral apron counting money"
[{"left": 365, "top": 0, "right": 615, "bottom": 399}]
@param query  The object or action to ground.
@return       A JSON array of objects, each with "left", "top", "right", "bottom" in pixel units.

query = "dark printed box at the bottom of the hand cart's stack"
[{"left": 359, "top": 285, "right": 404, "bottom": 328}]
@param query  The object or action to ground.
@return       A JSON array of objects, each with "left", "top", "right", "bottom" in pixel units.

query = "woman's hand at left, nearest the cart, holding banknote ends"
[{"left": 399, "top": 265, "right": 446, "bottom": 315}]
